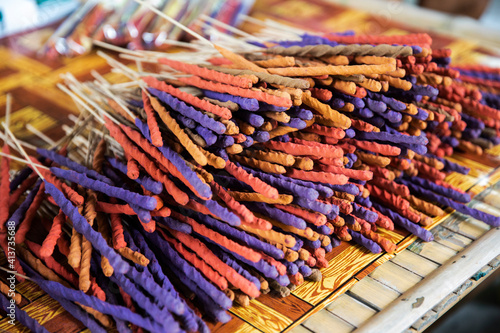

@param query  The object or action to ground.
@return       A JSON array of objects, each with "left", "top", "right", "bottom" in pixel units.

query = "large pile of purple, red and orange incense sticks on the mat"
[{"left": 0, "top": 17, "right": 500, "bottom": 332}]
